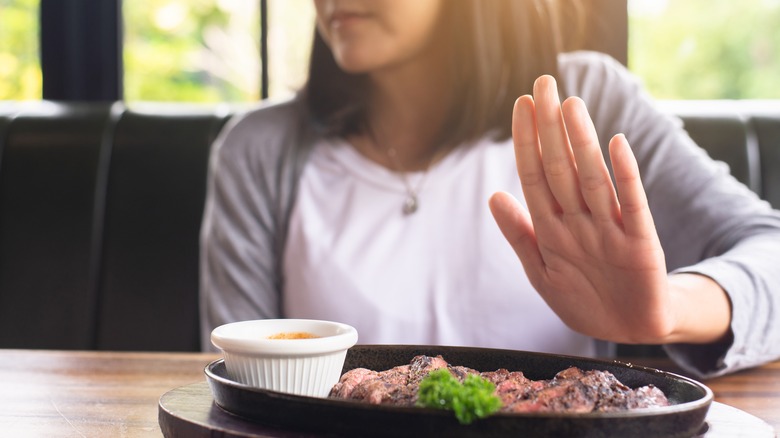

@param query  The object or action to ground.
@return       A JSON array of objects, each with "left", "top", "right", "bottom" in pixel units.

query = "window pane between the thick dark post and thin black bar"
[{"left": 122, "top": 0, "right": 261, "bottom": 102}]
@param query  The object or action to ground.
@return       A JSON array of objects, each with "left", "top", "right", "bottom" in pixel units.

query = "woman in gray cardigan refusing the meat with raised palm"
[{"left": 201, "top": 0, "right": 780, "bottom": 375}]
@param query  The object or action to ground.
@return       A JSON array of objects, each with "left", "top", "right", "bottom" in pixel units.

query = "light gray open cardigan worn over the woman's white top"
[{"left": 200, "top": 52, "right": 780, "bottom": 377}]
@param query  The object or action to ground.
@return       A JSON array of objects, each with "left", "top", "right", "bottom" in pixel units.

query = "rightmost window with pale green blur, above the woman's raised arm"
[{"left": 628, "top": 0, "right": 780, "bottom": 99}]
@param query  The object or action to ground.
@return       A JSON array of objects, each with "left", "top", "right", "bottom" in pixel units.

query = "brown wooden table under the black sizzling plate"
[{"left": 0, "top": 350, "right": 780, "bottom": 437}]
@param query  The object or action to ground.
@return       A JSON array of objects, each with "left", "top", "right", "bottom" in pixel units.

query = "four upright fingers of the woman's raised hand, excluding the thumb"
[{"left": 512, "top": 76, "right": 654, "bottom": 237}]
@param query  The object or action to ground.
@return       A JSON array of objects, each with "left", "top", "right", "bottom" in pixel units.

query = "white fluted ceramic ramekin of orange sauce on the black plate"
[{"left": 211, "top": 319, "right": 358, "bottom": 397}]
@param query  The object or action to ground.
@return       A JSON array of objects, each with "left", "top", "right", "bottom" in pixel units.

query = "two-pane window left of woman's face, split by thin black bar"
[{"left": 123, "top": 0, "right": 314, "bottom": 102}]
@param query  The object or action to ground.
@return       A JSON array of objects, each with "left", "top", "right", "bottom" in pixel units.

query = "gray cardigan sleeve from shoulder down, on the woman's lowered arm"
[{"left": 200, "top": 98, "right": 312, "bottom": 350}]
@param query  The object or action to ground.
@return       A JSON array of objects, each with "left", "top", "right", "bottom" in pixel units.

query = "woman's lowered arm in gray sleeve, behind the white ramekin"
[{"left": 200, "top": 111, "right": 279, "bottom": 350}]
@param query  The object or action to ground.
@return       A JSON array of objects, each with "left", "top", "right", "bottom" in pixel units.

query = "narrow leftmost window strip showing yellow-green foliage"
[{"left": 0, "top": 0, "right": 42, "bottom": 100}]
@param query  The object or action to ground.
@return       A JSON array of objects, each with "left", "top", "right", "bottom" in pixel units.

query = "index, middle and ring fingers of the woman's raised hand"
[{"left": 513, "top": 76, "right": 619, "bottom": 224}]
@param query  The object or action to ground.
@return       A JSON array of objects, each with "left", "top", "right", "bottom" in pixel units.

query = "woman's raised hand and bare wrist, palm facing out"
[{"left": 490, "top": 76, "right": 729, "bottom": 343}]
